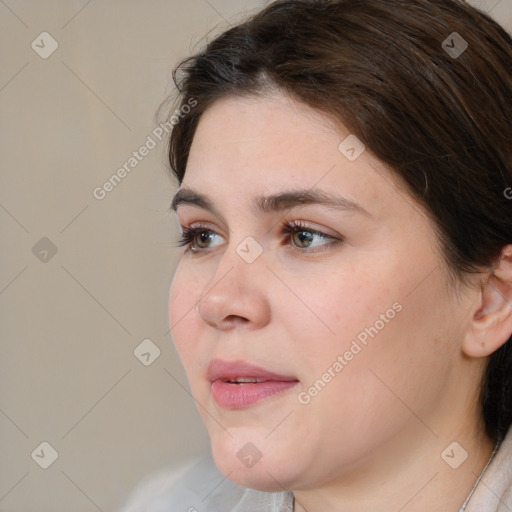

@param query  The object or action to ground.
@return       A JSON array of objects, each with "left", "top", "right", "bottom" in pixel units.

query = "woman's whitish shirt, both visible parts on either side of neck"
[{"left": 120, "top": 428, "right": 512, "bottom": 512}]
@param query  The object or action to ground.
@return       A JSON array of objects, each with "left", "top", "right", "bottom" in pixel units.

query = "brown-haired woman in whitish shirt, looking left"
[{"left": 122, "top": 0, "right": 512, "bottom": 512}]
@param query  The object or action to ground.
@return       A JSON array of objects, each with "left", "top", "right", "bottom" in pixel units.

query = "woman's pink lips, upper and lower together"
[{"left": 207, "top": 359, "right": 299, "bottom": 409}]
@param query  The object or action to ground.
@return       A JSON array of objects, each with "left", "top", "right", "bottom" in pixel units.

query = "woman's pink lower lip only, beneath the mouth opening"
[{"left": 212, "top": 380, "right": 298, "bottom": 409}]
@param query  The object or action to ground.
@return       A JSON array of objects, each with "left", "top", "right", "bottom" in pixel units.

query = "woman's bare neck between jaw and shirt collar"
[{"left": 294, "top": 429, "right": 494, "bottom": 512}]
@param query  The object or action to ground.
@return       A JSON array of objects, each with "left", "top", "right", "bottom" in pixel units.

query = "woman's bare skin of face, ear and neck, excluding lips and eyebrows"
[{"left": 169, "top": 92, "right": 512, "bottom": 512}]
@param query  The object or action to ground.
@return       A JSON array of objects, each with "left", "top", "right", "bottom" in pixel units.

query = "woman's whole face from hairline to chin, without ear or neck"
[{"left": 169, "top": 94, "right": 477, "bottom": 490}]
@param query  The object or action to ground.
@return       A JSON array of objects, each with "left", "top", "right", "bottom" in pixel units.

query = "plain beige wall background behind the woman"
[{"left": 0, "top": 0, "right": 512, "bottom": 512}]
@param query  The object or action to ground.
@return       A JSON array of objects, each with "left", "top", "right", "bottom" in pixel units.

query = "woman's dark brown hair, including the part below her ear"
[{"left": 169, "top": 0, "right": 512, "bottom": 440}]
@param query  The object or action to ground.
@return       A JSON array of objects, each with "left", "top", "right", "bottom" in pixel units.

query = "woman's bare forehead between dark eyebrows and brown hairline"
[{"left": 182, "top": 93, "right": 406, "bottom": 220}]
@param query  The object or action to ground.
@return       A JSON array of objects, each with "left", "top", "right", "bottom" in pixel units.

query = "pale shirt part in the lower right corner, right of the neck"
[{"left": 466, "top": 427, "right": 512, "bottom": 512}]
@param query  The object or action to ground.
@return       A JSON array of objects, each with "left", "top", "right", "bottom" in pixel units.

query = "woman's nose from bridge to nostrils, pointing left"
[{"left": 196, "top": 248, "right": 271, "bottom": 330}]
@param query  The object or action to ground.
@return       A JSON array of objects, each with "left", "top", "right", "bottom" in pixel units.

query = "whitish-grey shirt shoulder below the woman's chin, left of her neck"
[{"left": 119, "top": 456, "right": 293, "bottom": 512}]
